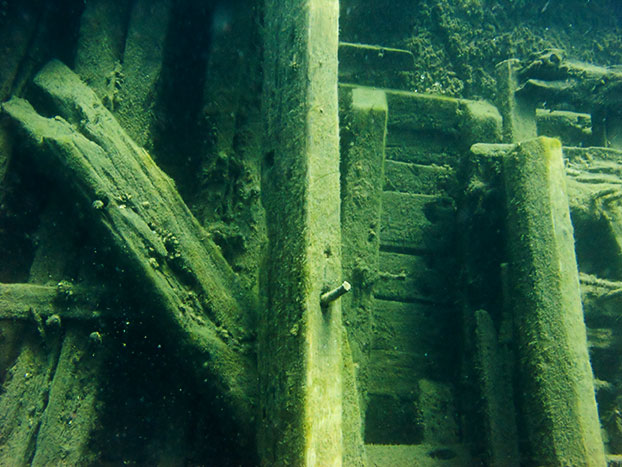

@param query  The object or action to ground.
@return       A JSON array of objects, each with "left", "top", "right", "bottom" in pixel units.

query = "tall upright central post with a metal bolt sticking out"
[{"left": 259, "top": 0, "right": 352, "bottom": 465}]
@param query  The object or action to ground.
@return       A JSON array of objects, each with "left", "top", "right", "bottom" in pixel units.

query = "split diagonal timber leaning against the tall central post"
[{"left": 3, "top": 61, "right": 257, "bottom": 434}]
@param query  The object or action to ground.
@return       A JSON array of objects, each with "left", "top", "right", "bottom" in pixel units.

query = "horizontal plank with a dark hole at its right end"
[{"left": 380, "top": 192, "right": 454, "bottom": 252}]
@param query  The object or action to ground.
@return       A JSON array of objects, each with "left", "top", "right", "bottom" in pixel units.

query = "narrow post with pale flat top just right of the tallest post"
[{"left": 339, "top": 86, "right": 388, "bottom": 420}]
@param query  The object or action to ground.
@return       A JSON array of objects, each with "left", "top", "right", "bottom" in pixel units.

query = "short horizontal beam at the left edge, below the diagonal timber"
[{"left": 0, "top": 281, "right": 103, "bottom": 320}]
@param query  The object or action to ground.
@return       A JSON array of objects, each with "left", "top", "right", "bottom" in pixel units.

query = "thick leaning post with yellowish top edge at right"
[{"left": 504, "top": 137, "right": 606, "bottom": 466}]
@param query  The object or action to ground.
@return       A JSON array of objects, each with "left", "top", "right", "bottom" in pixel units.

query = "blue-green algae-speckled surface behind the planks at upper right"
[{"left": 341, "top": 0, "right": 622, "bottom": 100}]
